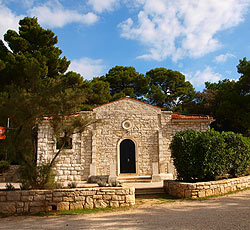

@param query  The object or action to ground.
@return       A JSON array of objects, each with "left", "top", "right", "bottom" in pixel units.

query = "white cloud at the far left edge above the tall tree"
[{"left": 0, "top": 3, "right": 24, "bottom": 40}]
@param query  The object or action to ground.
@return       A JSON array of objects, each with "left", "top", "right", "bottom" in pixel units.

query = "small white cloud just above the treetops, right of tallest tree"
[{"left": 69, "top": 57, "right": 107, "bottom": 80}]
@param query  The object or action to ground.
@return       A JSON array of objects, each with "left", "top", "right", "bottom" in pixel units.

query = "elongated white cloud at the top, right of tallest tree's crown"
[{"left": 28, "top": 0, "right": 98, "bottom": 28}]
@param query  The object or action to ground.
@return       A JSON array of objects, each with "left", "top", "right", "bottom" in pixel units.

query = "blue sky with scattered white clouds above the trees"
[{"left": 0, "top": 0, "right": 250, "bottom": 90}]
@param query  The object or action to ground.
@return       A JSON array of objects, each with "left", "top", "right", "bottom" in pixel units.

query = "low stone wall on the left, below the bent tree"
[{"left": 0, "top": 187, "right": 135, "bottom": 214}]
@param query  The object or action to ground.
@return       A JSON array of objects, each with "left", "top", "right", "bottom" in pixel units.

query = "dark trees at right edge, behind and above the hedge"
[{"left": 184, "top": 58, "right": 250, "bottom": 136}]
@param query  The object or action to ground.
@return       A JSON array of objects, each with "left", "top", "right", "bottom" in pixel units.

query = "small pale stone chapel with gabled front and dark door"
[{"left": 37, "top": 97, "right": 213, "bottom": 183}]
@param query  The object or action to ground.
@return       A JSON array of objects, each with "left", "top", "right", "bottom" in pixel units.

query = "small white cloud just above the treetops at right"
[{"left": 184, "top": 66, "right": 224, "bottom": 89}]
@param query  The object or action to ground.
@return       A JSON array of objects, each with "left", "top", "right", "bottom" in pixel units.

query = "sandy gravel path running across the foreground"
[{"left": 0, "top": 190, "right": 250, "bottom": 230}]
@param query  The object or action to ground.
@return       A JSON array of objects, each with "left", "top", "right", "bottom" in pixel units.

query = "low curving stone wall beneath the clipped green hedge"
[{"left": 164, "top": 176, "right": 250, "bottom": 198}]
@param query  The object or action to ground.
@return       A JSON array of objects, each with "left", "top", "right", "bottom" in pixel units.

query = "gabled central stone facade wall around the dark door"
[{"left": 93, "top": 99, "right": 161, "bottom": 176}]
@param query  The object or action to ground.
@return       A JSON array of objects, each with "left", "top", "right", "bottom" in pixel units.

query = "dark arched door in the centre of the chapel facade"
[{"left": 120, "top": 139, "right": 136, "bottom": 173}]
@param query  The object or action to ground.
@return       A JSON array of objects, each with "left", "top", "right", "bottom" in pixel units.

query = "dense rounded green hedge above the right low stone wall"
[{"left": 171, "top": 130, "right": 250, "bottom": 182}]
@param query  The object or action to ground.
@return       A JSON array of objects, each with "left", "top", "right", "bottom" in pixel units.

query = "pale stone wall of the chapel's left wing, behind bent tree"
[{"left": 37, "top": 112, "right": 92, "bottom": 182}]
